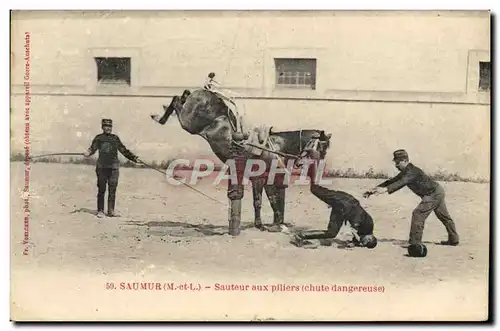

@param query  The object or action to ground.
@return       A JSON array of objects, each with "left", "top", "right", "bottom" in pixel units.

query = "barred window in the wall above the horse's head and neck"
[{"left": 274, "top": 59, "right": 316, "bottom": 90}]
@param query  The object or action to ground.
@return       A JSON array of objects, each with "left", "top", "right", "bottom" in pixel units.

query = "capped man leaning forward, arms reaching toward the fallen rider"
[{"left": 364, "top": 149, "right": 459, "bottom": 246}]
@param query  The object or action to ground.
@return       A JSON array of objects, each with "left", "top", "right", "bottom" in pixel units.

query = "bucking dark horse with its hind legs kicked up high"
[{"left": 151, "top": 89, "right": 331, "bottom": 235}]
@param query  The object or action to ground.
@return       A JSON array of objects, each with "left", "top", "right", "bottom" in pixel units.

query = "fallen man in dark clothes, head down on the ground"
[{"left": 295, "top": 150, "right": 377, "bottom": 248}]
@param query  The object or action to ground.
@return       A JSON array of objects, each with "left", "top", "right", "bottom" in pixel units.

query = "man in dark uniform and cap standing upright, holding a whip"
[{"left": 84, "top": 119, "right": 141, "bottom": 218}]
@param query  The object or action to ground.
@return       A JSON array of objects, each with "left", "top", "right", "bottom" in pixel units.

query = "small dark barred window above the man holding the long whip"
[{"left": 95, "top": 57, "right": 131, "bottom": 85}]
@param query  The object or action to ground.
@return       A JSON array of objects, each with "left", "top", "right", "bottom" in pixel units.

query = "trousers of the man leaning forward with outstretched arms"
[{"left": 409, "top": 185, "right": 458, "bottom": 245}]
